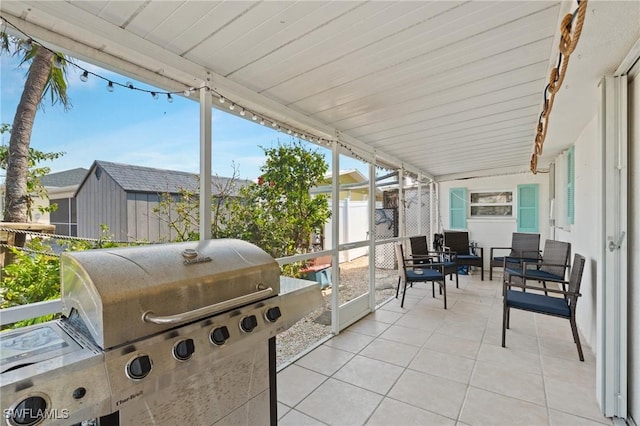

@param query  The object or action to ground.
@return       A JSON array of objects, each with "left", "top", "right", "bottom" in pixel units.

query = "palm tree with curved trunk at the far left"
[{"left": 0, "top": 33, "right": 71, "bottom": 222}]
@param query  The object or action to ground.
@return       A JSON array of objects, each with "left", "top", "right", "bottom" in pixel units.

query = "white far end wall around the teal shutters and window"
[{"left": 434, "top": 173, "right": 549, "bottom": 272}]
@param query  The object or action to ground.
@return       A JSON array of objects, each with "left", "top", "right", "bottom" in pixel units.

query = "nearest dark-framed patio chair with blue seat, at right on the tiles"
[{"left": 502, "top": 254, "right": 585, "bottom": 361}]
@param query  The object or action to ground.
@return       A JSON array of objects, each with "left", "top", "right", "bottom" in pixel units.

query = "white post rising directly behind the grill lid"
[{"left": 200, "top": 87, "right": 211, "bottom": 240}]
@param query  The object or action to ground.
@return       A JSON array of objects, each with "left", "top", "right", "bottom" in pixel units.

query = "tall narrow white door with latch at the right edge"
[{"left": 596, "top": 75, "right": 628, "bottom": 419}]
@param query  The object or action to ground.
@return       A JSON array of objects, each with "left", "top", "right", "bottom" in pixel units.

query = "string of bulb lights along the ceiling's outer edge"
[{"left": 0, "top": 16, "right": 378, "bottom": 163}]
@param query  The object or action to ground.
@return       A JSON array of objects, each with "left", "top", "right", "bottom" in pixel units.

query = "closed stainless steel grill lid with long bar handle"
[{"left": 60, "top": 239, "right": 280, "bottom": 349}]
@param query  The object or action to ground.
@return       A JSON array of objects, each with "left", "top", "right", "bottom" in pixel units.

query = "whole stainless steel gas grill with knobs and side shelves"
[{"left": 0, "top": 240, "right": 323, "bottom": 425}]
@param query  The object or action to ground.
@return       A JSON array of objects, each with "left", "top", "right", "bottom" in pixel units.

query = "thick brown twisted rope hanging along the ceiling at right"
[{"left": 530, "top": 0, "right": 587, "bottom": 174}]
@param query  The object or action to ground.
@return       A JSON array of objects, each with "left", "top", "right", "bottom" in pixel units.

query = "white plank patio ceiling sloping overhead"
[{"left": 0, "top": 0, "right": 640, "bottom": 179}]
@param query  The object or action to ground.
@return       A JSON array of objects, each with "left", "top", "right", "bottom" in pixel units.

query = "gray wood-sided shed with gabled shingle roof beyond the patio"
[{"left": 75, "top": 161, "right": 250, "bottom": 241}]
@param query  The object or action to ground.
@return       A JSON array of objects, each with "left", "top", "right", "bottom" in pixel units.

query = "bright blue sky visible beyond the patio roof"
[{"left": 0, "top": 50, "right": 366, "bottom": 180}]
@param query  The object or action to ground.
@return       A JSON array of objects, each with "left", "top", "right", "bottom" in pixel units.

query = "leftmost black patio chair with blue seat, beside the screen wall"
[{"left": 395, "top": 244, "right": 447, "bottom": 309}]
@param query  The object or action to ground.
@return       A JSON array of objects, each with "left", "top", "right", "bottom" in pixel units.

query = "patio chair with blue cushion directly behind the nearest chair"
[{"left": 503, "top": 240, "right": 571, "bottom": 294}]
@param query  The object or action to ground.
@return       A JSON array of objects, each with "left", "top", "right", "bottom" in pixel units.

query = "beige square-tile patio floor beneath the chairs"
[{"left": 278, "top": 274, "right": 612, "bottom": 426}]
